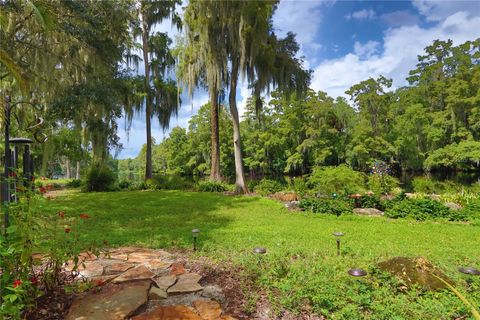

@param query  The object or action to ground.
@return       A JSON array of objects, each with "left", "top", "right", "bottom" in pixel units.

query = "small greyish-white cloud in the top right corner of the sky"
[{"left": 412, "top": 0, "right": 480, "bottom": 21}]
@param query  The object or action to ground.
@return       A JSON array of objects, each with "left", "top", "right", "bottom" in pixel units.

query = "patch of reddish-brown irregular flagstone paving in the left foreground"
[{"left": 65, "top": 247, "right": 235, "bottom": 320}]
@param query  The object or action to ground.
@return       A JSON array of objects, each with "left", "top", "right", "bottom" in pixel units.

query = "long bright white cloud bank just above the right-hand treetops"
[{"left": 311, "top": 12, "right": 480, "bottom": 97}]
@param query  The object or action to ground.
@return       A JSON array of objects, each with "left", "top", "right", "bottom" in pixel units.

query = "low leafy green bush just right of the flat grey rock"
[{"left": 385, "top": 199, "right": 468, "bottom": 221}]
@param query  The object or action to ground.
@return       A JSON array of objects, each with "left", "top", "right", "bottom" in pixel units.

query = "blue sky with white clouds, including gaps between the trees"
[{"left": 119, "top": 0, "right": 480, "bottom": 159}]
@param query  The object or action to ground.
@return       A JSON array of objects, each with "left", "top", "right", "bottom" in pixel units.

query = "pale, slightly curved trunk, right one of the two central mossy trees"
[{"left": 228, "top": 60, "right": 248, "bottom": 193}]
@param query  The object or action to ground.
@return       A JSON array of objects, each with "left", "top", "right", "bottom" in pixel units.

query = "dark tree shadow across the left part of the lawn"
[{"left": 49, "top": 191, "right": 259, "bottom": 248}]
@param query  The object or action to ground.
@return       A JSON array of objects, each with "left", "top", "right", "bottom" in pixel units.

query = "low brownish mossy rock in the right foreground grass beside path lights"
[{"left": 378, "top": 257, "right": 453, "bottom": 290}]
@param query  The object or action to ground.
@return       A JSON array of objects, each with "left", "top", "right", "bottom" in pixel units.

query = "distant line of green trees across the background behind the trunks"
[{"left": 118, "top": 39, "right": 480, "bottom": 179}]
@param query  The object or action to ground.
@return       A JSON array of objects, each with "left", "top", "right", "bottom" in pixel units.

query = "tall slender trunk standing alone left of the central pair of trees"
[{"left": 142, "top": 14, "right": 152, "bottom": 180}]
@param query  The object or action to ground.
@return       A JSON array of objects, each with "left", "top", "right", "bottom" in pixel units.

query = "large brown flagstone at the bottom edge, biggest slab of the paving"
[{"left": 65, "top": 281, "right": 151, "bottom": 320}]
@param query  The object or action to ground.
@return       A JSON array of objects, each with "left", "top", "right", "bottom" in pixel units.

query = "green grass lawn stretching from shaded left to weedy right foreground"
[{"left": 49, "top": 191, "right": 480, "bottom": 319}]
